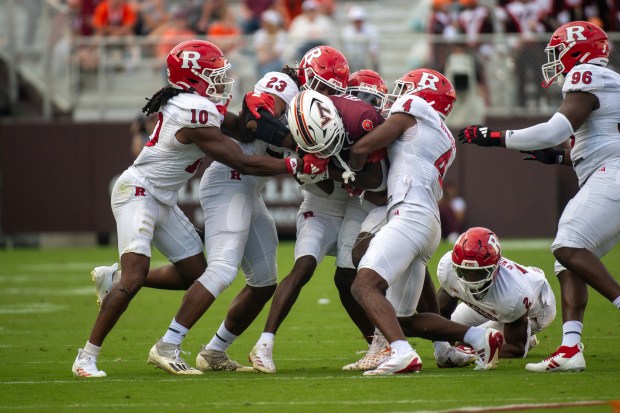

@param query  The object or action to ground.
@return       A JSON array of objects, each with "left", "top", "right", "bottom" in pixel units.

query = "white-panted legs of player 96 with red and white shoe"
[{"left": 526, "top": 168, "right": 620, "bottom": 372}]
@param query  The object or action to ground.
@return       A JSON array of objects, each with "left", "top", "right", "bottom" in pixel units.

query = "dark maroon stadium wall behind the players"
[{"left": 0, "top": 119, "right": 577, "bottom": 237}]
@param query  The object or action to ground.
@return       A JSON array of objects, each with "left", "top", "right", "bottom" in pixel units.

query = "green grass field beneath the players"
[{"left": 0, "top": 241, "right": 620, "bottom": 413}]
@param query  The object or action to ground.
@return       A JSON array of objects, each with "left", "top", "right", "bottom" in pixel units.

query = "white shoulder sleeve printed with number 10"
[{"left": 168, "top": 93, "right": 224, "bottom": 128}]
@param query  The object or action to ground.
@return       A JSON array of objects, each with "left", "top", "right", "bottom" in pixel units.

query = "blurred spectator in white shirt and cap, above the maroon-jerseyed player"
[{"left": 341, "top": 5, "right": 379, "bottom": 72}]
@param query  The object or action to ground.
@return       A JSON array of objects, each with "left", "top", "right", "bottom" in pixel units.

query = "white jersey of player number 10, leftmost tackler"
[{"left": 128, "top": 93, "right": 224, "bottom": 205}]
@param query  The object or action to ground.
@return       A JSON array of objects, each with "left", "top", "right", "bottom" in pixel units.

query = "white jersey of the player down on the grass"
[{"left": 437, "top": 251, "right": 555, "bottom": 323}]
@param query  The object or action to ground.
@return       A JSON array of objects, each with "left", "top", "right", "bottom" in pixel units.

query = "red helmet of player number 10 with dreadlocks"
[{"left": 166, "top": 40, "right": 234, "bottom": 103}]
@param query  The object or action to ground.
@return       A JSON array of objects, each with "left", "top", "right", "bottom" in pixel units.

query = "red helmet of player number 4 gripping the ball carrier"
[{"left": 382, "top": 69, "right": 456, "bottom": 119}]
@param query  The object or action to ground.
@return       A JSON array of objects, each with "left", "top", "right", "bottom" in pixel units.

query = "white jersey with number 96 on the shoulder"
[{"left": 562, "top": 64, "right": 620, "bottom": 186}]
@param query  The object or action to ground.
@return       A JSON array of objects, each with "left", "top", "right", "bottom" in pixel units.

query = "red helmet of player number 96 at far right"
[{"left": 542, "top": 21, "right": 609, "bottom": 87}]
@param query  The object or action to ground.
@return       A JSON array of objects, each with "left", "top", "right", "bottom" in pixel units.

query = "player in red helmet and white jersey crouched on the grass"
[{"left": 437, "top": 227, "right": 556, "bottom": 357}]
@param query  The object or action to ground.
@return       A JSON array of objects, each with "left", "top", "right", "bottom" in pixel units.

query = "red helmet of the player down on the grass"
[{"left": 452, "top": 227, "right": 502, "bottom": 297}]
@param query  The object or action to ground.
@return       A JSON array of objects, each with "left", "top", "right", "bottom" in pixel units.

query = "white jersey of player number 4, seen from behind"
[{"left": 388, "top": 95, "right": 456, "bottom": 219}]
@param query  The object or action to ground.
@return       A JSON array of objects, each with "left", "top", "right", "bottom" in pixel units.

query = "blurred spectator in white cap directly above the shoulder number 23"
[{"left": 254, "top": 10, "right": 288, "bottom": 77}]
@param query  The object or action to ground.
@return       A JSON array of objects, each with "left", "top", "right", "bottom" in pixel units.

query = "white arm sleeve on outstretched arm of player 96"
[{"left": 506, "top": 112, "right": 574, "bottom": 151}]
